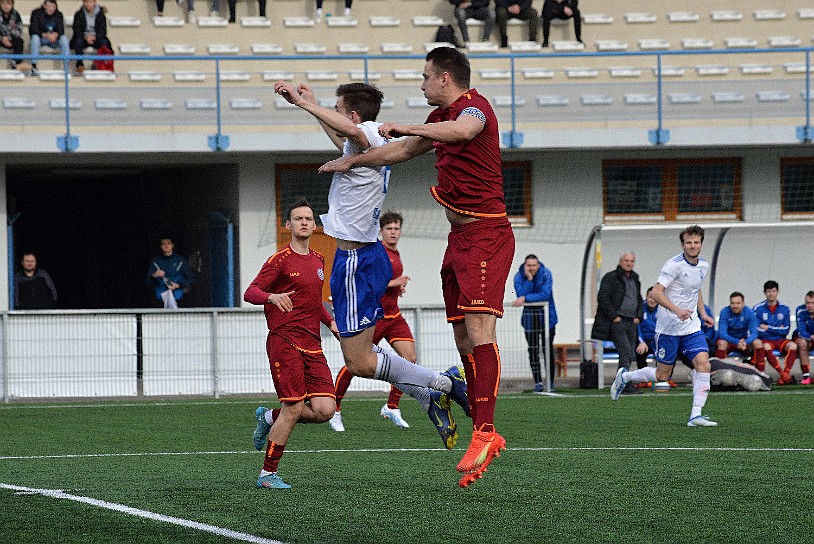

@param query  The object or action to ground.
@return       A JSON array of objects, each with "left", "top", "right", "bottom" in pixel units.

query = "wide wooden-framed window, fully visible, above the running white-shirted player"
[{"left": 602, "top": 158, "right": 741, "bottom": 221}]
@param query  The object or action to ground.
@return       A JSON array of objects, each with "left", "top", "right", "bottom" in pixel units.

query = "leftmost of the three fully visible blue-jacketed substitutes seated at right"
[{"left": 715, "top": 291, "right": 782, "bottom": 373}]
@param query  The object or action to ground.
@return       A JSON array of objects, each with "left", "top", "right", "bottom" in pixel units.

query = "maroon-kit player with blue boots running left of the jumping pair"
[{"left": 243, "top": 200, "right": 338, "bottom": 489}]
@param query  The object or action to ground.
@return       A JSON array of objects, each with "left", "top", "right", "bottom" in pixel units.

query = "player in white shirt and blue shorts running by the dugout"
[{"left": 610, "top": 225, "right": 718, "bottom": 427}]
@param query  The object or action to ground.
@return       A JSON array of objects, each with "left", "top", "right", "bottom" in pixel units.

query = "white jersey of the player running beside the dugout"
[{"left": 656, "top": 253, "right": 709, "bottom": 336}]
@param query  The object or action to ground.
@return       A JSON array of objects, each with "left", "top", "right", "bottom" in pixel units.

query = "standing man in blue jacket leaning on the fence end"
[{"left": 512, "top": 255, "right": 557, "bottom": 393}]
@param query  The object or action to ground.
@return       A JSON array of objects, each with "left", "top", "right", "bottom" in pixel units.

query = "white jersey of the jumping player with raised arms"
[{"left": 319, "top": 121, "right": 390, "bottom": 242}]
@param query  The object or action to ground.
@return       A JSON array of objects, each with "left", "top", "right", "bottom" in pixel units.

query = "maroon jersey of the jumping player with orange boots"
[{"left": 426, "top": 89, "right": 506, "bottom": 217}]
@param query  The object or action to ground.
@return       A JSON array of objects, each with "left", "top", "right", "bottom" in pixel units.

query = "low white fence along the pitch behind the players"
[{"left": 0, "top": 305, "right": 545, "bottom": 402}]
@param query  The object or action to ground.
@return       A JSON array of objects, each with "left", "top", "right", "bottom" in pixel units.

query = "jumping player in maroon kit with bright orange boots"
[{"left": 320, "top": 47, "right": 514, "bottom": 487}]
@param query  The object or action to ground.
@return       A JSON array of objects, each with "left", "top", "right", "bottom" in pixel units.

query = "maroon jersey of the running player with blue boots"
[{"left": 243, "top": 246, "right": 331, "bottom": 351}]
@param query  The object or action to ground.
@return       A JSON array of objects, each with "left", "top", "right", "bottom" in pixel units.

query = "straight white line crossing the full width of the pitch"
[{"left": 0, "top": 446, "right": 814, "bottom": 462}]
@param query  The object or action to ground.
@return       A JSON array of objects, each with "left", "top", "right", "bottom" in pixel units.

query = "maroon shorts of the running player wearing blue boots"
[{"left": 266, "top": 334, "right": 334, "bottom": 402}]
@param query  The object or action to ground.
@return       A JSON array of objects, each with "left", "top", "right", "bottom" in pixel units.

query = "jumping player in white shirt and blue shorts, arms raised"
[{"left": 274, "top": 77, "right": 469, "bottom": 449}]
